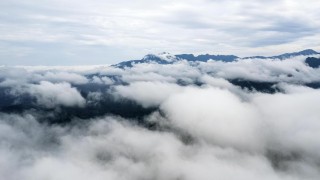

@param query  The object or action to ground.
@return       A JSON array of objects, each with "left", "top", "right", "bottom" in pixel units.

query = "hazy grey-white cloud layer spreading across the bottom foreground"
[{"left": 0, "top": 114, "right": 319, "bottom": 180}]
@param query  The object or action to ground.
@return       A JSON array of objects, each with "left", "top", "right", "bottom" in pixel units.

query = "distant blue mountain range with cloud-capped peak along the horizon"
[{"left": 112, "top": 49, "right": 320, "bottom": 68}]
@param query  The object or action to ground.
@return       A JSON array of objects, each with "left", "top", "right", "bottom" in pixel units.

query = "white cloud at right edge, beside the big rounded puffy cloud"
[{"left": 253, "top": 86, "right": 320, "bottom": 157}]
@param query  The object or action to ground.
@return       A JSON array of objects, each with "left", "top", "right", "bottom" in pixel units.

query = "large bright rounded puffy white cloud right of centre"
[{"left": 161, "top": 88, "right": 264, "bottom": 150}]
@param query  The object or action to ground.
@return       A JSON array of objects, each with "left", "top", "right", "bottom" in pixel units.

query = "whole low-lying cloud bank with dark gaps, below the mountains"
[{"left": 0, "top": 57, "right": 320, "bottom": 180}]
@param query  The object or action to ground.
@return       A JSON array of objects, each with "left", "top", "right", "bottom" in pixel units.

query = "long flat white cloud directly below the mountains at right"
[{"left": 199, "top": 56, "right": 320, "bottom": 83}]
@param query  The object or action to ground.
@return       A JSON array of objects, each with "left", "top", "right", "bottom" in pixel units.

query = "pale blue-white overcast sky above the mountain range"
[{"left": 0, "top": 0, "right": 320, "bottom": 65}]
